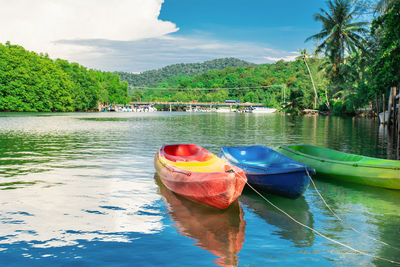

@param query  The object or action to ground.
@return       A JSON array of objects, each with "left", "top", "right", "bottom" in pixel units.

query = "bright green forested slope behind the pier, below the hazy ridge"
[{"left": 132, "top": 58, "right": 327, "bottom": 113}]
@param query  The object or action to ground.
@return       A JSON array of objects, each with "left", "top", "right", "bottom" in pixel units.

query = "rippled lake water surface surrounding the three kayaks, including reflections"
[{"left": 0, "top": 112, "right": 400, "bottom": 266}]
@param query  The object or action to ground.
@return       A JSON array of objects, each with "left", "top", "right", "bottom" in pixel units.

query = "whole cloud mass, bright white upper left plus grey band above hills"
[{"left": 0, "top": 0, "right": 296, "bottom": 72}]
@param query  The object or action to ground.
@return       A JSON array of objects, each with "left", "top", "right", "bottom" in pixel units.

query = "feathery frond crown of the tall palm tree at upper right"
[{"left": 306, "top": 0, "right": 368, "bottom": 77}]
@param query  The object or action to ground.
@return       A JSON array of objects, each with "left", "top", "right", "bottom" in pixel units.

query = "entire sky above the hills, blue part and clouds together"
[{"left": 0, "top": 0, "right": 325, "bottom": 72}]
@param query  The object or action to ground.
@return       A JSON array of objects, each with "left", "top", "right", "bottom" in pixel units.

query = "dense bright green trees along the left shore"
[{"left": 0, "top": 43, "right": 129, "bottom": 111}]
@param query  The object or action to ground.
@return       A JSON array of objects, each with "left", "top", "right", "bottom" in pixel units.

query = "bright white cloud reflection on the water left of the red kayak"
[{"left": 0, "top": 173, "right": 163, "bottom": 247}]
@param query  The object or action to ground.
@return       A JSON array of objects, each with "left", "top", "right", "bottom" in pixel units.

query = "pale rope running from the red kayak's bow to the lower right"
[{"left": 231, "top": 171, "right": 400, "bottom": 265}]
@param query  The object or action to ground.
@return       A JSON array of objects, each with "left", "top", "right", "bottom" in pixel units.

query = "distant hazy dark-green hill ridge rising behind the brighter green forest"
[{"left": 117, "top": 58, "right": 255, "bottom": 87}]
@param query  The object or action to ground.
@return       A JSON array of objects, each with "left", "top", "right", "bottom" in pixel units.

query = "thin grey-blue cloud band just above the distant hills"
[{"left": 59, "top": 36, "right": 297, "bottom": 72}]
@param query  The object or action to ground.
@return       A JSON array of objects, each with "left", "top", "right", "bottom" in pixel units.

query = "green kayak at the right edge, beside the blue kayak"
[{"left": 276, "top": 145, "right": 400, "bottom": 189}]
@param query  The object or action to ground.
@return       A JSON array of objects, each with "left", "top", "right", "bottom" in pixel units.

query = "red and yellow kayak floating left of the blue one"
[{"left": 154, "top": 144, "right": 247, "bottom": 209}]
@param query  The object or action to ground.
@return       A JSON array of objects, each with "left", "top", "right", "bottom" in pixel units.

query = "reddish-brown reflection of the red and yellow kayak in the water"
[{"left": 154, "top": 174, "right": 246, "bottom": 266}]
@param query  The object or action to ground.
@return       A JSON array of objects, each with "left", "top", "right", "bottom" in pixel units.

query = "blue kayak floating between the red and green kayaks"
[{"left": 219, "top": 146, "right": 315, "bottom": 198}]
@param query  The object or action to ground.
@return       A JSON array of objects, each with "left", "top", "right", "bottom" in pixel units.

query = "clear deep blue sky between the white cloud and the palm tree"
[{"left": 159, "top": 0, "right": 325, "bottom": 51}]
